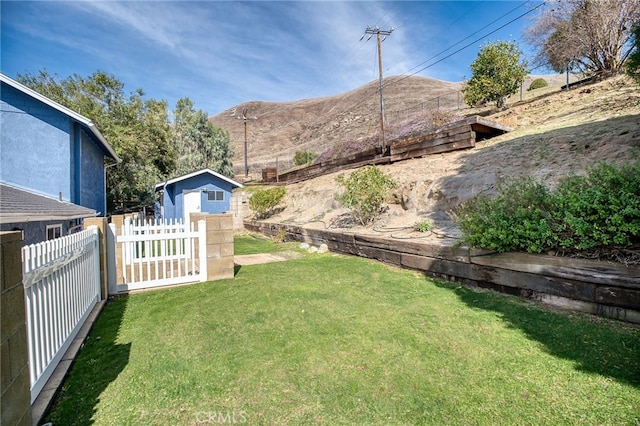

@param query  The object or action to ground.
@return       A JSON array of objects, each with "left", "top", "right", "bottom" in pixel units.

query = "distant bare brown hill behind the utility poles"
[{"left": 209, "top": 75, "right": 575, "bottom": 177}]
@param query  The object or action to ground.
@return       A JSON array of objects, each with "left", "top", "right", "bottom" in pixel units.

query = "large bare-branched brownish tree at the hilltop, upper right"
[{"left": 527, "top": 0, "right": 640, "bottom": 73}]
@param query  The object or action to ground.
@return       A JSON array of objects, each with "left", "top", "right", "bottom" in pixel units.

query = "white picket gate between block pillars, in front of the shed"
[{"left": 109, "top": 218, "right": 207, "bottom": 292}]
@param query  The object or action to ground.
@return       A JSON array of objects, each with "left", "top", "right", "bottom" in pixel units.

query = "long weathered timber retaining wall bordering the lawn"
[{"left": 245, "top": 221, "right": 640, "bottom": 324}]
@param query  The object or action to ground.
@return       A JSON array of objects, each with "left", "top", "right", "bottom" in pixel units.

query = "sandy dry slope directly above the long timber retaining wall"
[{"left": 254, "top": 77, "right": 640, "bottom": 236}]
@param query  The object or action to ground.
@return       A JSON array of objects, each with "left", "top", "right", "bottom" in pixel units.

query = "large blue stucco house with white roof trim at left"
[{"left": 0, "top": 73, "right": 120, "bottom": 244}]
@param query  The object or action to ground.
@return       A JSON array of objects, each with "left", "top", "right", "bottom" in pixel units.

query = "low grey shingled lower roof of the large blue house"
[{"left": 0, "top": 183, "right": 97, "bottom": 223}]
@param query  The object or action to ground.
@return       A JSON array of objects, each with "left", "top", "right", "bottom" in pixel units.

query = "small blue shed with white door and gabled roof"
[{"left": 155, "top": 169, "right": 242, "bottom": 221}]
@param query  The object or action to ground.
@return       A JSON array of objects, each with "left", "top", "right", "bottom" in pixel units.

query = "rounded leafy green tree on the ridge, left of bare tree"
[{"left": 463, "top": 41, "right": 527, "bottom": 108}]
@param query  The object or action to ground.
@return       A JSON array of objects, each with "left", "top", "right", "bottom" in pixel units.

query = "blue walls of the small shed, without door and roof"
[{"left": 163, "top": 173, "right": 233, "bottom": 219}]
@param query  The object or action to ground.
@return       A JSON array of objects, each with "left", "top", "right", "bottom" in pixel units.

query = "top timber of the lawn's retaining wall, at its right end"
[{"left": 471, "top": 253, "right": 640, "bottom": 289}]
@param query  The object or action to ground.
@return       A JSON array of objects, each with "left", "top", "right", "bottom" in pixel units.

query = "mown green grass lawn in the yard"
[{"left": 47, "top": 237, "right": 640, "bottom": 425}]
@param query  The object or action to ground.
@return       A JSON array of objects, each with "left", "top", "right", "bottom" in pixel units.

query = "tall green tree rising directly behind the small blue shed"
[{"left": 173, "top": 98, "right": 233, "bottom": 177}]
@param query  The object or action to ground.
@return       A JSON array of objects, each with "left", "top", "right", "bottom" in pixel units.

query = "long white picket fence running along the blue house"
[{"left": 22, "top": 227, "right": 100, "bottom": 403}]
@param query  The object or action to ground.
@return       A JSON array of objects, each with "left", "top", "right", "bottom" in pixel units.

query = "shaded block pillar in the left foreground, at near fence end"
[{"left": 0, "top": 232, "right": 31, "bottom": 425}]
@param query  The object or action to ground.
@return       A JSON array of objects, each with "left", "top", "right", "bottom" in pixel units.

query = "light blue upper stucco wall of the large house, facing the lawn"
[{"left": 0, "top": 84, "right": 72, "bottom": 201}]
